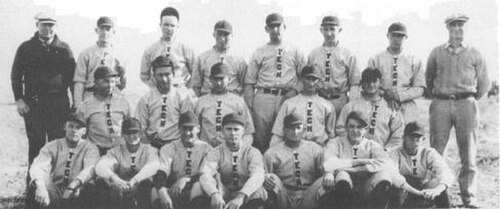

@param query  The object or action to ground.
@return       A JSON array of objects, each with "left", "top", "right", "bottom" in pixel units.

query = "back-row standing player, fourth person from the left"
[{"left": 191, "top": 20, "right": 247, "bottom": 97}]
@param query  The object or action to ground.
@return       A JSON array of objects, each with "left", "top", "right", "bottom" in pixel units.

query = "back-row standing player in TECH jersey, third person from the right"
[{"left": 307, "top": 16, "right": 361, "bottom": 116}]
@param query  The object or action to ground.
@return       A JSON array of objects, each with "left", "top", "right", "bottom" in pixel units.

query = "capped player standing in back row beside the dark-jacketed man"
[{"left": 73, "top": 17, "right": 126, "bottom": 108}]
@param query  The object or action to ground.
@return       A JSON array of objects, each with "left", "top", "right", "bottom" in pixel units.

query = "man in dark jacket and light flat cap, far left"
[{"left": 11, "top": 13, "right": 75, "bottom": 165}]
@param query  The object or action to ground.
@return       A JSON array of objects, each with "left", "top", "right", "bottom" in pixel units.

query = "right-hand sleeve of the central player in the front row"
[{"left": 240, "top": 149, "right": 264, "bottom": 197}]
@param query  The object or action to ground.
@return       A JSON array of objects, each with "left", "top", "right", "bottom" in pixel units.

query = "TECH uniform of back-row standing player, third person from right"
[{"left": 307, "top": 44, "right": 361, "bottom": 115}]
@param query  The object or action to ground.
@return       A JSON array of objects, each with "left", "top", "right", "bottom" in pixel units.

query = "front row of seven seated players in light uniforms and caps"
[{"left": 27, "top": 108, "right": 453, "bottom": 208}]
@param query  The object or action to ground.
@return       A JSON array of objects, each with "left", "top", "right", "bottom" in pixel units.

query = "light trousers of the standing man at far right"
[{"left": 429, "top": 97, "right": 479, "bottom": 203}]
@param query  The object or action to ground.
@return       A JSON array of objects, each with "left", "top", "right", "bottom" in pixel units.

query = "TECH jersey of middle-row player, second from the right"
[{"left": 271, "top": 94, "right": 336, "bottom": 146}]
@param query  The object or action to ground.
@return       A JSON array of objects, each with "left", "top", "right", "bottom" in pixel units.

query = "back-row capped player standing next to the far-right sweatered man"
[{"left": 368, "top": 22, "right": 425, "bottom": 121}]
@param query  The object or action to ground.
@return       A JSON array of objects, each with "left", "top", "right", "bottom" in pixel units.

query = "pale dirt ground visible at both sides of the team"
[{"left": 0, "top": 94, "right": 500, "bottom": 208}]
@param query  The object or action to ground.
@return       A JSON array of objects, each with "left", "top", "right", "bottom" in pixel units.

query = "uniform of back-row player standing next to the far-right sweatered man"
[{"left": 368, "top": 50, "right": 425, "bottom": 122}]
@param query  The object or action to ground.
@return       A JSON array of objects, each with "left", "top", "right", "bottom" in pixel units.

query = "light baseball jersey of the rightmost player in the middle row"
[{"left": 335, "top": 97, "right": 404, "bottom": 150}]
